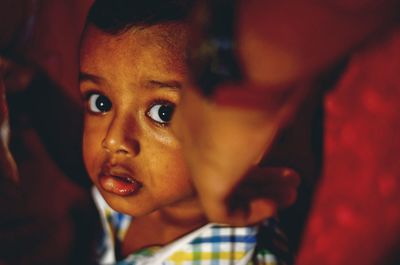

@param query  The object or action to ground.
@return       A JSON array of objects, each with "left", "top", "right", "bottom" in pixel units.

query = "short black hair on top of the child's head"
[{"left": 86, "top": 0, "right": 194, "bottom": 35}]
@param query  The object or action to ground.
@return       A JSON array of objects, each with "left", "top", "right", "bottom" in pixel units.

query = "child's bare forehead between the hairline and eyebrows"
[{"left": 80, "top": 23, "right": 187, "bottom": 79}]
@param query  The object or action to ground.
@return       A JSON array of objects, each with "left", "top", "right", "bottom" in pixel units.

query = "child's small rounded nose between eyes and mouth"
[{"left": 102, "top": 114, "right": 140, "bottom": 156}]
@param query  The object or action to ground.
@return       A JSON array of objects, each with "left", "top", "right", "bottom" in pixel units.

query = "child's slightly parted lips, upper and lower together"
[{"left": 99, "top": 165, "right": 142, "bottom": 196}]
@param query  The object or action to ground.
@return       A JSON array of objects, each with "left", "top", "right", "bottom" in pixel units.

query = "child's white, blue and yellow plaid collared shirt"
[{"left": 93, "top": 189, "right": 285, "bottom": 265}]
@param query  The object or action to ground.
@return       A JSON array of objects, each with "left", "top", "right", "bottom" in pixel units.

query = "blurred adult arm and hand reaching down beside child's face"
[{"left": 173, "top": 0, "right": 398, "bottom": 225}]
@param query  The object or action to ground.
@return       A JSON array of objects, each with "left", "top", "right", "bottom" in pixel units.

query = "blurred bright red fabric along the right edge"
[{"left": 297, "top": 28, "right": 400, "bottom": 265}]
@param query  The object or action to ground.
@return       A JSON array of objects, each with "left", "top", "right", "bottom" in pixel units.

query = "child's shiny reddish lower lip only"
[{"left": 99, "top": 175, "right": 142, "bottom": 196}]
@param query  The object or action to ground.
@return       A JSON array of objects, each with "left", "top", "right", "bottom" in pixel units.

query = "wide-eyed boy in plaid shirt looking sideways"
[{"left": 80, "top": 0, "right": 290, "bottom": 264}]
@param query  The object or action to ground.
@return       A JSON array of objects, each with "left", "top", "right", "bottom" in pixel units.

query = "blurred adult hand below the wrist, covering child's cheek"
[{"left": 172, "top": 83, "right": 302, "bottom": 225}]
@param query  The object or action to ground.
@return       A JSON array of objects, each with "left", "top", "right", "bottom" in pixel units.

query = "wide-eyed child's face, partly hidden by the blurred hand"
[{"left": 80, "top": 25, "right": 196, "bottom": 216}]
